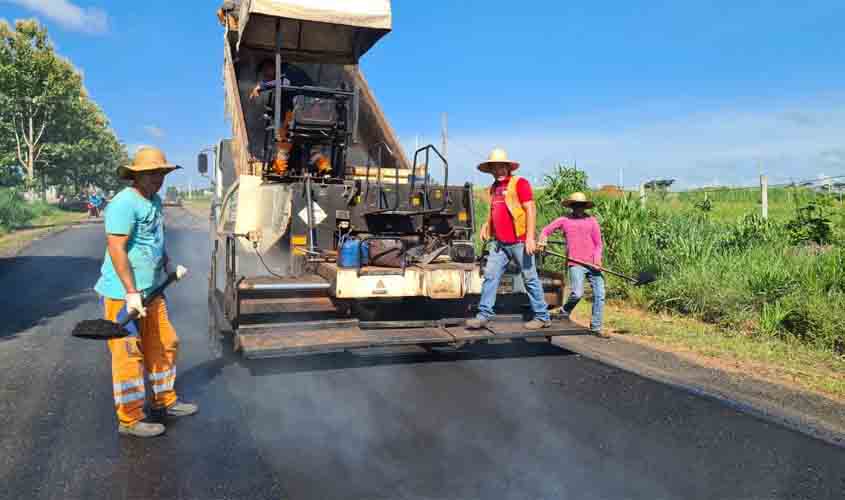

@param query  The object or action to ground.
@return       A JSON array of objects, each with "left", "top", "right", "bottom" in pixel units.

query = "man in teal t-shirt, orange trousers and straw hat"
[{"left": 94, "top": 147, "right": 198, "bottom": 437}]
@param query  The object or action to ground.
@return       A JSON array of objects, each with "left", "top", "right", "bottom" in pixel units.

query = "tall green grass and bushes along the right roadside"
[{"left": 476, "top": 166, "right": 845, "bottom": 364}]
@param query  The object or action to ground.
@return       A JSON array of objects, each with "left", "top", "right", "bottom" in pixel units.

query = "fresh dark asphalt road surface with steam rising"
[{"left": 0, "top": 209, "right": 845, "bottom": 500}]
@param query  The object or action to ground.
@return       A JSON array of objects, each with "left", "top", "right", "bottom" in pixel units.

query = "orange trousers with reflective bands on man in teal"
[{"left": 104, "top": 297, "right": 179, "bottom": 425}]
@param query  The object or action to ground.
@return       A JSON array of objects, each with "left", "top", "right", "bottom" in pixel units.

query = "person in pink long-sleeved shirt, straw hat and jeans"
[{"left": 538, "top": 193, "right": 607, "bottom": 338}]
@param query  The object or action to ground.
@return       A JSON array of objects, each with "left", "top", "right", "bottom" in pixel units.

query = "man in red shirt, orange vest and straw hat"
[{"left": 466, "top": 149, "right": 551, "bottom": 330}]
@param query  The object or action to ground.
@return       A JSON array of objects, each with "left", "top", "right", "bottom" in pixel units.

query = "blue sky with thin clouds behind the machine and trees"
[{"left": 0, "top": 0, "right": 845, "bottom": 187}]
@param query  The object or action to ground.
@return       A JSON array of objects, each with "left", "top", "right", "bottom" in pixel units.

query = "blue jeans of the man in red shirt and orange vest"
[{"left": 477, "top": 241, "right": 551, "bottom": 321}]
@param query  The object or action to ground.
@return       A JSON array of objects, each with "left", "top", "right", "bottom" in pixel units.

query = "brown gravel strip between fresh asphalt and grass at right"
[{"left": 552, "top": 336, "right": 845, "bottom": 448}]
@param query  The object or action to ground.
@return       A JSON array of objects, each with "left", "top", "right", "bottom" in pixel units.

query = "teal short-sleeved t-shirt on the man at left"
[{"left": 94, "top": 187, "right": 165, "bottom": 299}]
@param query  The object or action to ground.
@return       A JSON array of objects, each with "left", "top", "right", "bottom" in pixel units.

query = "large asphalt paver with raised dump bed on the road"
[{"left": 206, "top": 0, "right": 574, "bottom": 358}]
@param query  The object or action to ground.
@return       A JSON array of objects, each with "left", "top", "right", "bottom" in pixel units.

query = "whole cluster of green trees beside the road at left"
[{"left": 0, "top": 21, "right": 128, "bottom": 198}]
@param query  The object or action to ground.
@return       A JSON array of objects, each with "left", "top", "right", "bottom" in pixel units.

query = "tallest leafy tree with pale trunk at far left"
[{"left": 0, "top": 20, "right": 88, "bottom": 186}]
